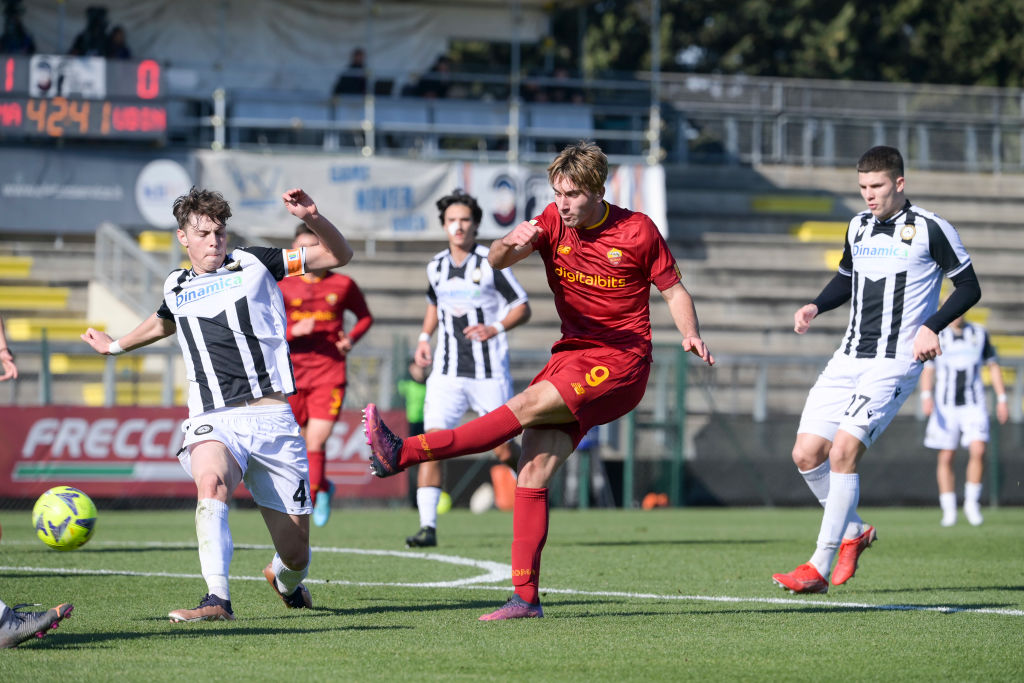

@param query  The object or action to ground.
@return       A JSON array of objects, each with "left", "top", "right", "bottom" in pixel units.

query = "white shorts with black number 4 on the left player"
[{"left": 178, "top": 405, "right": 313, "bottom": 515}]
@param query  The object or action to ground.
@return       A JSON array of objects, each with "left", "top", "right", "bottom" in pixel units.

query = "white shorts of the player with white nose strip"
[{"left": 423, "top": 374, "right": 512, "bottom": 431}]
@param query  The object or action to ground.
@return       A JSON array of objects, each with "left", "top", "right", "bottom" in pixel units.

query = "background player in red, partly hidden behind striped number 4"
[{"left": 278, "top": 223, "right": 374, "bottom": 526}]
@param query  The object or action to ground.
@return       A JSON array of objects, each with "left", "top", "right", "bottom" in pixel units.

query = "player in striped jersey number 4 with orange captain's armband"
[{"left": 82, "top": 187, "right": 352, "bottom": 623}]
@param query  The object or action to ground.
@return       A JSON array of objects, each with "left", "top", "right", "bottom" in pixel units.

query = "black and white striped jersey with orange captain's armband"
[{"left": 151, "top": 247, "right": 305, "bottom": 416}]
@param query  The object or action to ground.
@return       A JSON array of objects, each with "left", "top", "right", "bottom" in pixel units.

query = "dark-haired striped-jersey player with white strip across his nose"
[{"left": 406, "top": 189, "right": 529, "bottom": 548}]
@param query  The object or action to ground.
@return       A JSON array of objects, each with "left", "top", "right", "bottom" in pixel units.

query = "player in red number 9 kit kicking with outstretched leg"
[{"left": 365, "top": 142, "right": 715, "bottom": 622}]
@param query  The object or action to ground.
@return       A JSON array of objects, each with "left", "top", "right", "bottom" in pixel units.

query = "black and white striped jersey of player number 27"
[{"left": 839, "top": 202, "right": 971, "bottom": 359}]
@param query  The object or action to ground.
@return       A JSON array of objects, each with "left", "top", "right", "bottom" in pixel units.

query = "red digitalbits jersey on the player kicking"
[{"left": 534, "top": 202, "right": 680, "bottom": 358}]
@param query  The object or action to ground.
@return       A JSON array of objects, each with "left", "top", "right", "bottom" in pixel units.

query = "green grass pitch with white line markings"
[{"left": 0, "top": 508, "right": 1024, "bottom": 682}]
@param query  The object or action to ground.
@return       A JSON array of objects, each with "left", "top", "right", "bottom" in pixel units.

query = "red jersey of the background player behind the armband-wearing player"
[{"left": 278, "top": 272, "right": 373, "bottom": 387}]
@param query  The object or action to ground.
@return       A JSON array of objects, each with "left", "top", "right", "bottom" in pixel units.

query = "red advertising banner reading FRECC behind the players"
[{"left": 0, "top": 405, "right": 408, "bottom": 499}]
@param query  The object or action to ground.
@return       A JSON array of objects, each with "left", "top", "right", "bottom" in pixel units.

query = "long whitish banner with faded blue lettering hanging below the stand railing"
[{"left": 197, "top": 151, "right": 668, "bottom": 240}]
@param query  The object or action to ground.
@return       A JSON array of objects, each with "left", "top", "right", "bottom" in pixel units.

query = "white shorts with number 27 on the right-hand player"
[{"left": 797, "top": 352, "right": 924, "bottom": 447}]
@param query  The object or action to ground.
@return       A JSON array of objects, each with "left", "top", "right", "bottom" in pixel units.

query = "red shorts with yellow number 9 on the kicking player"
[{"left": 530, "top": 346, "right": 650, "bottom": 449}]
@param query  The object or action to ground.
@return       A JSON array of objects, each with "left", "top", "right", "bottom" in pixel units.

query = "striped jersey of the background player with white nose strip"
[{"left": 427, "top": 245, "right": 526, "bottom": 379}]
